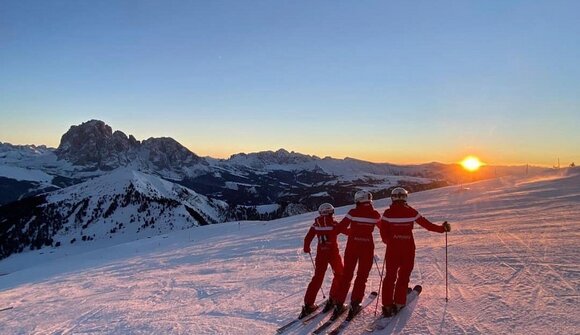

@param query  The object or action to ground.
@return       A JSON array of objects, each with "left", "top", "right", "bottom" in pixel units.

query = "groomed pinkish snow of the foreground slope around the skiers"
[{"left": 0, "top": 168, "right": 580, "bottom": 334}]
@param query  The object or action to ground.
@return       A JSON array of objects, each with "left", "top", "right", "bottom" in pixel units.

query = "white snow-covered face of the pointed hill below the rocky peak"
[{"left": 37, "top": 168, "right": 228, "bottom": 251}]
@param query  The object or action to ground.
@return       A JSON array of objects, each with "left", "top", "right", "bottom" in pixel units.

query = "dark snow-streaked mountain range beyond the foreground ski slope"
[{"left": 0, "top": 120, "right": 539, "bottom": 259}]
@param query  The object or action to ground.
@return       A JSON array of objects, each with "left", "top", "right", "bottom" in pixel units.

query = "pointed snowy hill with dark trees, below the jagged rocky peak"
[{"left": 0, "top": 168, "right": 228, "bottom": 258}]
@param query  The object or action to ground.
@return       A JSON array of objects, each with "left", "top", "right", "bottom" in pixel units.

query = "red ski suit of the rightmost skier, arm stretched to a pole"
[{"left": 379, "top": 201, "right": 445, "bottom": 306}]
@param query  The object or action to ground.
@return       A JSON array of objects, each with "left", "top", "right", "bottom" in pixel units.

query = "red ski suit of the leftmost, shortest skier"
[{"left": 304, "top": 215, "right": 343, "bottom": 306}]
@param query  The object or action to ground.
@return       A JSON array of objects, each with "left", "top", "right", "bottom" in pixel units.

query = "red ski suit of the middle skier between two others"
[{"left": 335, "top": 202, "right": 381, "bottom": 305}]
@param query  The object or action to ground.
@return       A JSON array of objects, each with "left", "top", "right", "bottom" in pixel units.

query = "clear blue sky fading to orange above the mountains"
[{"left": 0, "top": 0, "right": 580, "bottom": 165}]
